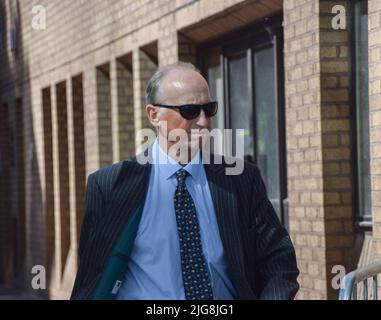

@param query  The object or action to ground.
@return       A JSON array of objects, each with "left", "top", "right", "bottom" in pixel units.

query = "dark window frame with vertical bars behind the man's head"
[{"left": 197, "top": 14, "right": 289, "bottom": 229}]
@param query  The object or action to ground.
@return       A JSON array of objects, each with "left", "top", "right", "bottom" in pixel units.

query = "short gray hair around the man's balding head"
[{"left": 146, "top": 61, "right": 201, "bottom": 104}]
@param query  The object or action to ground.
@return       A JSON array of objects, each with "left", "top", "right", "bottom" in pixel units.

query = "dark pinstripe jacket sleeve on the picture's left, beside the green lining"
[{"left": 71, "top": 174, "right": 104, "bottom": 299}]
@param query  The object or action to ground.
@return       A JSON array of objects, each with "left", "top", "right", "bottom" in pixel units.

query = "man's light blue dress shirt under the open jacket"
[{"left": 117, "top": 140, "right": 236, "bottom": 300}]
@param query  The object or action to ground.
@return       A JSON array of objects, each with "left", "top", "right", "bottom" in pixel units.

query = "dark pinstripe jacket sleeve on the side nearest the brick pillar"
[{"left": 254, "top": 168, "right": 299, "bottom": 300}]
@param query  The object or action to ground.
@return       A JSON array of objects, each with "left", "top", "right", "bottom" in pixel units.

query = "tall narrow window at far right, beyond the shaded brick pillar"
[{"left": 353, "top": 0, "right": 372, "bottom": 227}]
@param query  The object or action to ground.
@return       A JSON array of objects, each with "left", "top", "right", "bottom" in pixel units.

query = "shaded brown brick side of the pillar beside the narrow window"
[{"left": 320, "top": 1, "right": 359, "bottom": 299}]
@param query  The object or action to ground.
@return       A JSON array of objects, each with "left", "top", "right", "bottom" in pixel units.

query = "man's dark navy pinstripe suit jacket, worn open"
[{"left": 71, "top": 152, "right": 299, "bottom": 299}]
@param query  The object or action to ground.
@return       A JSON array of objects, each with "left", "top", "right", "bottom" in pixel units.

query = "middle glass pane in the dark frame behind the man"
[{"left": 229, "top": 54, "right": 254, "bottom": 156}]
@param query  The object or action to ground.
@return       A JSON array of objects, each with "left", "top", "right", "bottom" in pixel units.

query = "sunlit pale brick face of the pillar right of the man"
[{"left": 284, "top": 0, "right": 327, "bottom": 299}]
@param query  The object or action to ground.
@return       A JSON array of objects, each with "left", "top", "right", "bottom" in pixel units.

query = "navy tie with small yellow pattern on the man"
[{"left": 173, "top": 169, "right": 213, "bottom": 300}]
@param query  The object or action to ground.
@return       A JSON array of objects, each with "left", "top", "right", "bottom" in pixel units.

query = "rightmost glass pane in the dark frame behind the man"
[{"left": 254, "top": 47, "right": 280, "bottom": 212}]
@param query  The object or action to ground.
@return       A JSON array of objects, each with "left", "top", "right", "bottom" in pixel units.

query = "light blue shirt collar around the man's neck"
[{"left": 152, "top": 139, "right": 203, "bottom": 181}]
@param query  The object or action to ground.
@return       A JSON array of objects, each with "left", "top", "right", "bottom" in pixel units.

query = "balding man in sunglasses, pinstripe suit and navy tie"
[{"left": 72, "top": 63, "right": 299, "bottom": 300}]
